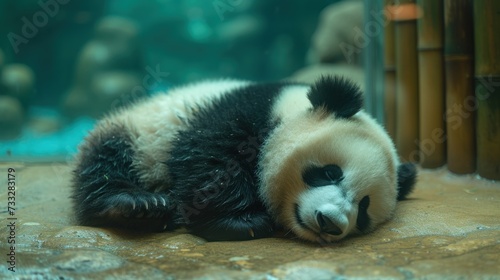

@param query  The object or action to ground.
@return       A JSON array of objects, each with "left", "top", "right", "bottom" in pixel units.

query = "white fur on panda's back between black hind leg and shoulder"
[{"left": 120, "top": 80, "right": 252, "bottom": 188}]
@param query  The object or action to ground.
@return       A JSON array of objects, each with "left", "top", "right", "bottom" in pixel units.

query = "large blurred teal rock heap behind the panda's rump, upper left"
[{"left": 62, "top": 16, "right": 145, "bottom": 118}]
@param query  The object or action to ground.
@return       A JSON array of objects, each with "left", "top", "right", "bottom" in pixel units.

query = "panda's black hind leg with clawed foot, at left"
[{"left": 72, "top": 124, "right": 174, "bottom": 231}]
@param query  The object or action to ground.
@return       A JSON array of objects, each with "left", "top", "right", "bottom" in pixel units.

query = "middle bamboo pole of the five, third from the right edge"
[{"left": 417, "top": 0, "right": 446, "bottom": 168}]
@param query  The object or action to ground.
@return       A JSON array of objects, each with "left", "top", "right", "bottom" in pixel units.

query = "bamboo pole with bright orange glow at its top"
[{"left": 393, "top": 0, "right": 419, "bottom": 162}]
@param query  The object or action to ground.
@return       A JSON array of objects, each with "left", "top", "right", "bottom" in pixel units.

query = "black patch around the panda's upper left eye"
[{"left": 302, "top": 164, "right": 344, "bottom": 187}]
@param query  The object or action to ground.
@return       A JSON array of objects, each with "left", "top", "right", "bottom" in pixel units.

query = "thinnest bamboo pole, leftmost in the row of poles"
[{"left": 384, "top": 0, "right": 396, "bottom": 139}]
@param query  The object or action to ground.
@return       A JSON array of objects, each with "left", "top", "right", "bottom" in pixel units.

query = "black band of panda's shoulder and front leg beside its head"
[{"left": 167, "top": 84, "right": 285, "bottom": 240}]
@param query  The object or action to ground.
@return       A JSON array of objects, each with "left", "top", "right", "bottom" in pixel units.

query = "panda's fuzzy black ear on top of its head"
[{"left": 307, "top": 76, "right": 363, "bottom": 118}]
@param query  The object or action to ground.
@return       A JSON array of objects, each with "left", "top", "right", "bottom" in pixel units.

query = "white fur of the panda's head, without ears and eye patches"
[{"left": 259, "top": 87, "right": 399, "bottom": 242}]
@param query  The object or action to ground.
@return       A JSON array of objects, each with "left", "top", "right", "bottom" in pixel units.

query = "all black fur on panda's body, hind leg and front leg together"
[{"left": 73, "top": 83, "right": 287, "bottom": 241}]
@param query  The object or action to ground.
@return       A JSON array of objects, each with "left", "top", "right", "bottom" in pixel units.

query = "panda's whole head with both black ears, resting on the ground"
[{"left": 259, "top": 77, "right": 416, "bottom": 243}]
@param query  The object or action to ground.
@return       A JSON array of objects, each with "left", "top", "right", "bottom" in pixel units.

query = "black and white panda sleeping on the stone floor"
[{"left": 72, "top": 76, "right": 416, "bottom": 243}]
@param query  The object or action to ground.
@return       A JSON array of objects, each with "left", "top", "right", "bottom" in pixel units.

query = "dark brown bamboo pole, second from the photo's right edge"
[{"left": 444, "top": 0, "right": 476, "bottom": 174}]
